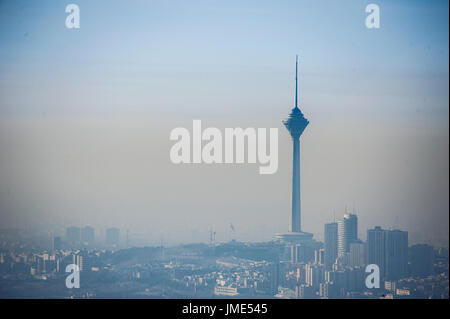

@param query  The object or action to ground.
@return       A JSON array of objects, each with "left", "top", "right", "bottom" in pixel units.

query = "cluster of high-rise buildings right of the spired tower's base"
[{"left": 278, "top": 214, "right": 442, "bottom": 298}]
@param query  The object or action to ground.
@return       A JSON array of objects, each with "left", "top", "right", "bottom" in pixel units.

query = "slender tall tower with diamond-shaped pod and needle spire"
[{"left": 283, "top": 57, "right": 309, "bottom": 233}]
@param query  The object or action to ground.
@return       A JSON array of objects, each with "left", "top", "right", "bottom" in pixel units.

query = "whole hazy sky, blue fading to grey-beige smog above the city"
[{"left": 0, "top": 0, "right": 449, "bottom": 246}]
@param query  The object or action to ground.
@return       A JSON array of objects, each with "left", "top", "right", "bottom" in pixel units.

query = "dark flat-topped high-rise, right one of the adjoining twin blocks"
[{"left": 385, "top": 229, "right": 408, "bottom": 280}]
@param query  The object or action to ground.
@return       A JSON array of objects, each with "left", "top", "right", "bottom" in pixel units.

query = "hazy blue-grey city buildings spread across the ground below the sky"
[{"left": 0, "top": 210, "right": 448, "bottom": 299}]
